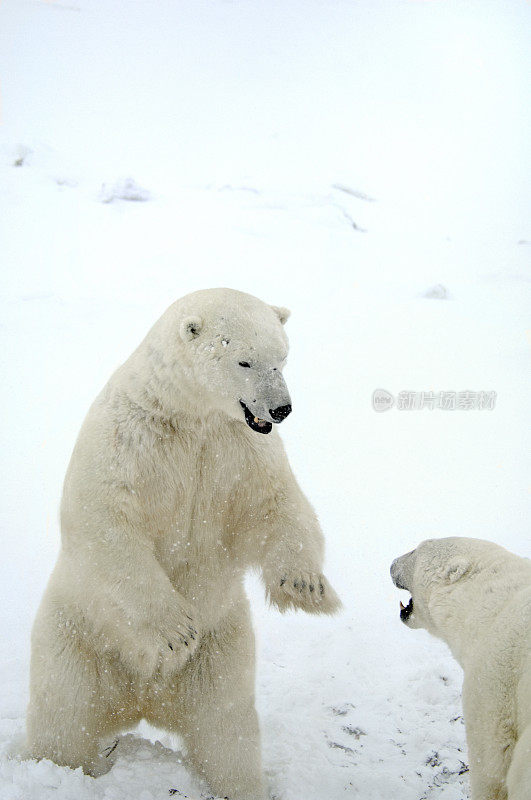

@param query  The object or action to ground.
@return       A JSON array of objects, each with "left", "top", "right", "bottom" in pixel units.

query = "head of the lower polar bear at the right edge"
[{"left": 391, "top": 537, "right": 517, "bottom": 640}]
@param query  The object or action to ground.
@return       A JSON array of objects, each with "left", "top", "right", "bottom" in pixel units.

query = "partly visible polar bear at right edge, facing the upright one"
[{"left": 391, "top": 538, "right": 531, "bottom": 800}]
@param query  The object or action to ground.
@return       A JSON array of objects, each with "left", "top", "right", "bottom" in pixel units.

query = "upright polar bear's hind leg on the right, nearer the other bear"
[{"left": 150, "top": 600, "right": 265, "bottom": 800}]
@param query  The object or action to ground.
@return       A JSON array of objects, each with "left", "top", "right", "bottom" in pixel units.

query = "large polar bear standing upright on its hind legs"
[{"left": 27, "top": 289, "right": 339, "bottom": 800}]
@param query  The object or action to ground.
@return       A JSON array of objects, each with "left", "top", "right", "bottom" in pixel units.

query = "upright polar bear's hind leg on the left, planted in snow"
[{"left": 27, "top": 610, "right": 140, "bottom": 777}]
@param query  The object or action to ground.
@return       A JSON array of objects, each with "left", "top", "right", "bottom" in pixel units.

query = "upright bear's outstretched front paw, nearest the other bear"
[{"left": 267, "top": 571, "right": 341, "bottom": 614}]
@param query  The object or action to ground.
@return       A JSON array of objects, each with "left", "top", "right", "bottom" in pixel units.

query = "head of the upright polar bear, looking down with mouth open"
[{"left": 149, "top": 289, "right": 291, "bottom": 434}]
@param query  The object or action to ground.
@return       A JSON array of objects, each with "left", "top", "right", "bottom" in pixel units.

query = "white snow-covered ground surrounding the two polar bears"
[{"left": 0, "top": 0, "right": 531, "bottom": 800}]
